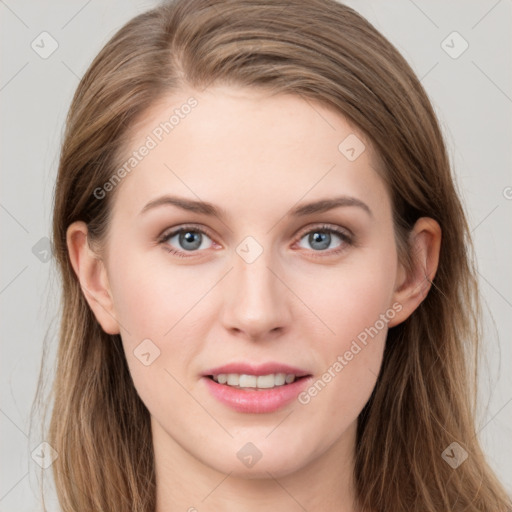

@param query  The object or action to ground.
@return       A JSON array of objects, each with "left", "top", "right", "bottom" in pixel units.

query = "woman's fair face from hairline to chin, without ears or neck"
[{"left": 91, "top": 86, "right": 401, "bottom": 477}]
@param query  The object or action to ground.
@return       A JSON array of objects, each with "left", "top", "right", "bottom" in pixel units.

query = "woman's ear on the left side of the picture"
[{"left": 66, "top": 221, "right": 120, "bottom": 334}]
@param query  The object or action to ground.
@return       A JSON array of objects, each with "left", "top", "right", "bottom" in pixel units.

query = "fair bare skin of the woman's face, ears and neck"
[{"left": 67, "top": 86, "right": 441, "bottom": 512}]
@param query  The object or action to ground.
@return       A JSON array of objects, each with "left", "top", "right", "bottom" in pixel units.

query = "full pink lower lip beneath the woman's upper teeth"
[{"left": 203, "top": 376, "right": 312, "bottom": 413}]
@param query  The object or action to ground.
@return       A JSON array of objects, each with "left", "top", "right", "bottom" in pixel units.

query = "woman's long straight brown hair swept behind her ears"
[{"left": 34, "top": 0, "right": 510, "bottom": 512}]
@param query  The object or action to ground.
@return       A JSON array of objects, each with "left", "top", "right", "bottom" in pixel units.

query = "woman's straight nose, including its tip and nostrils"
[{"left": 221, "top": 244, "right": 292, "bottom": 341}]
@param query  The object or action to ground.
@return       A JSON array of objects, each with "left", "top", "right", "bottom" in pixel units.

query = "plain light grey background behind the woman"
[{"left": 0, "top": 0, "right": 512, "bottom": 512}]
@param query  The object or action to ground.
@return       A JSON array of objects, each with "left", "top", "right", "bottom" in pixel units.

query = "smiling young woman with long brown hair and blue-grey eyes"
[{"left": 39, "top": 0, "right": 510, "bottom": 512}]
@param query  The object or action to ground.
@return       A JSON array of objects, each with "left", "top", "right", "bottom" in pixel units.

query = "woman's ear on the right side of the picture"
[{"left": 388, "top": 217, "right": 441, "bottom": 327}]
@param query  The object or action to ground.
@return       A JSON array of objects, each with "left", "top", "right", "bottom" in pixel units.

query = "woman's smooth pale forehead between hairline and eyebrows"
[{"left": 109, "top": 86, "right": 389, "bottom": 220}]
